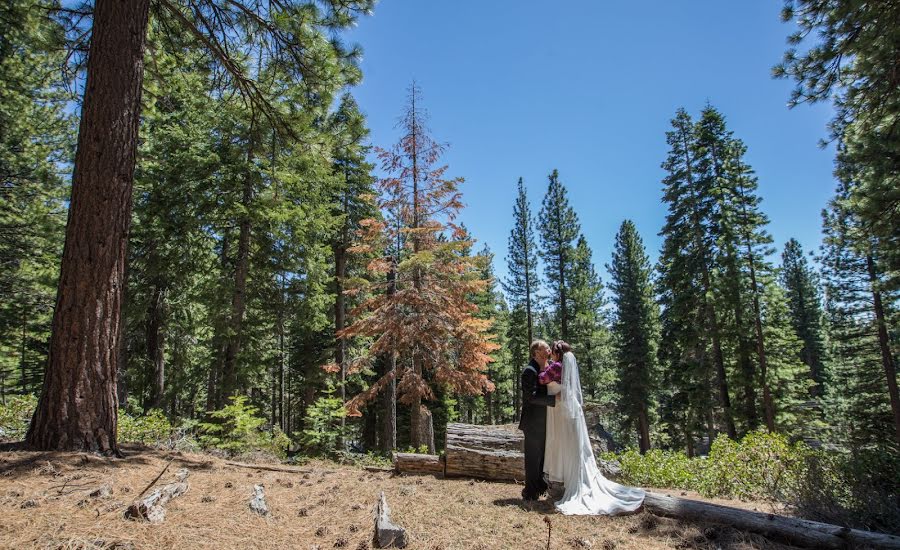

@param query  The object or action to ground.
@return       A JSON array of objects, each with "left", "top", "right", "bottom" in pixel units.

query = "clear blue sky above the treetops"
[{"left": 349, "top": 0, "right": 834, "bottom": 288}]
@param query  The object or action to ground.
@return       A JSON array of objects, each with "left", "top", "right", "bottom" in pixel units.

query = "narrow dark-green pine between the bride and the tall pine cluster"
[{"left": 607, "top": 220, "right": 659, "bottom": 453}]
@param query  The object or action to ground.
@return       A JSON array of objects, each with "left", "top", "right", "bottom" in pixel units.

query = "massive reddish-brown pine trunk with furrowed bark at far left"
[{"left": 27, "top": 0, "right": 150, "bottom": 453}]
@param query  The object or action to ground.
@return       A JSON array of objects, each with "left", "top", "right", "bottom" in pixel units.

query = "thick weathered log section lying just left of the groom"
[{"left": 444, "top": 423, "right": 525, "bottom": 481}]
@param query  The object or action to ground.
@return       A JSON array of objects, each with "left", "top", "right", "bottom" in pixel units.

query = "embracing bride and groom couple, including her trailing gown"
[{"left": 519, "top": 340, "right": 644, "bottom": 515}]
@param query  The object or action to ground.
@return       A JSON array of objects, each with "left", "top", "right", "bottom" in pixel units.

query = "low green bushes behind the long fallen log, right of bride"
[{"left": 601, "top": 431, "right": 900, "bottom": 533}]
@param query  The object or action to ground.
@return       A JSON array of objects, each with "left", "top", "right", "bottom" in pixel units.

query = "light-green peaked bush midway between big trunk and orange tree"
[{"left": 199, "top": 395, "right": 291, "bottom": 458}]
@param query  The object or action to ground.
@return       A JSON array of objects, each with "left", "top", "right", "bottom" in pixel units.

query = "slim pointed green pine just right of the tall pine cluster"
[{"left": 781, "top": 239, "right": 826, "bottom": 398}]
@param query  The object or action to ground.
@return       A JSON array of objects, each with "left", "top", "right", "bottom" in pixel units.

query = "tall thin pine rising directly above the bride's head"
[{"left": 538, "top": 170, "right": 581, "bottom": 340}]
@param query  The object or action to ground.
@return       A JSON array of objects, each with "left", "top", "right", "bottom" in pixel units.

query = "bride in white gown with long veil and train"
[{"left": 544, "top": 341, "right": 644, "bottom": 515}]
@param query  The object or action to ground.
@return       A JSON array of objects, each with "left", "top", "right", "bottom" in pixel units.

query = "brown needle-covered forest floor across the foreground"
[{"left": 0, "top": 447, "right": 792, "bottom": 550}]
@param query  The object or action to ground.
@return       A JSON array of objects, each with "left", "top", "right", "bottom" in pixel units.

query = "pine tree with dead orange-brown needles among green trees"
[{"left": 342, "top": 84, "right": 497, "bottom": 447}]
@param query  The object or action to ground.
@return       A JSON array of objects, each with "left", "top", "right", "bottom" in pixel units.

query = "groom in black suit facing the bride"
[{"left": 519, "top": 340, "right": 557, "bottom": 500}]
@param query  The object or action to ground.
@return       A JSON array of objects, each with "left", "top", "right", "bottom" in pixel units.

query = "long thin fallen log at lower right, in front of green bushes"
[{"left": 644, "top": 493, "right": 900, "bottom": 549}]
